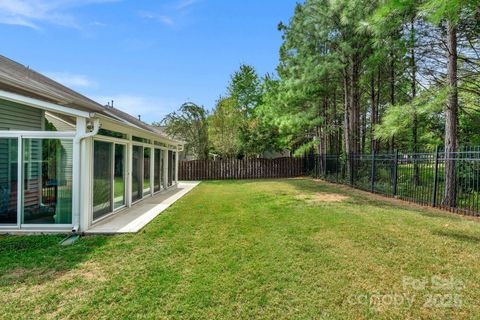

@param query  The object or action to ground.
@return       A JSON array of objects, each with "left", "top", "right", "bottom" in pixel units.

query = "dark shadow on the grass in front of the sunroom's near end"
[{"left": 0, "top": 235, "right": 109, "bottom": 287}]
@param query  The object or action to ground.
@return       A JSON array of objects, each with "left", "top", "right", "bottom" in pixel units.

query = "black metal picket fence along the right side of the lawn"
[{"left": 306, "top": 147, "right": 480, "bottom": 216}]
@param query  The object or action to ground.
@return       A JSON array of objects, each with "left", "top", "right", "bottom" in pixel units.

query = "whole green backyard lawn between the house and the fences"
[{"left": 0, "top": 179, "right": 480, "bottom": 319}]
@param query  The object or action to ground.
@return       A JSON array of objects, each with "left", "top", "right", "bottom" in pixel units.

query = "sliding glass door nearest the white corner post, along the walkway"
[{"left": 93, "top": 141, "right": 126, "bottom": 221}]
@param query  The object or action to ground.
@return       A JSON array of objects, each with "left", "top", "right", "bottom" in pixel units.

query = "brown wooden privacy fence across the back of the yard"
[{"left": 178, "top": 157, "right": 305, "bottom": 180}]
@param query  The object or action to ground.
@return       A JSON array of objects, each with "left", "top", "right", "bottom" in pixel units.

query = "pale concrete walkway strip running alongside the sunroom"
[{"left": 85, "top": 181, "right": 200, "bottom": 235}]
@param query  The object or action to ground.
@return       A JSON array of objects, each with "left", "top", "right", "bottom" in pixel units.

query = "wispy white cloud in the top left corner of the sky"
[{"left": 0, "top": 0, "right": 118, "bottom": 29}]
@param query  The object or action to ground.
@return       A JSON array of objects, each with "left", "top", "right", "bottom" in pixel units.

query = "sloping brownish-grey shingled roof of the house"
[{"left": 0, "top": 55, "right": 180, "bottom": 143}]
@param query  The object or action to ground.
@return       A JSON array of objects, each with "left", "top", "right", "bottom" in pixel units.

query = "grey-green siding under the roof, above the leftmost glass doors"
[{"left": 0, "top": 100, "right": 45, "bottom": 131}]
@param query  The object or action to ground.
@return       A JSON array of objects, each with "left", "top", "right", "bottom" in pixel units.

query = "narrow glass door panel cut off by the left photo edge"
[{"left": 0, "top": 138, "right": 18, "bottom": 226}]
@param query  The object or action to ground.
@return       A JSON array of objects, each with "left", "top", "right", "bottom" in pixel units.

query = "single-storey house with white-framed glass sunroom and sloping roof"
[{"left": 0, "top": 56, "right": 183, "bottom": 232}]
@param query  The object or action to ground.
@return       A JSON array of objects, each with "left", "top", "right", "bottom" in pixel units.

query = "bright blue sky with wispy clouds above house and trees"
[{"left": 0, "top": 0, "right": 297, "bottom": 122}]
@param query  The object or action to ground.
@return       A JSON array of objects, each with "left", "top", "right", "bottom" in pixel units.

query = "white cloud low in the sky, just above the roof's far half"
[{"left": 93, "top": 94, "right": 180, "bottom": 123}]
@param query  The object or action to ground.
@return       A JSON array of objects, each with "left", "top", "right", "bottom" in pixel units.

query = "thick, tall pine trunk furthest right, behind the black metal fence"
[{"left": 443, "top": 21, "right": 458, "bottom": 207}]
